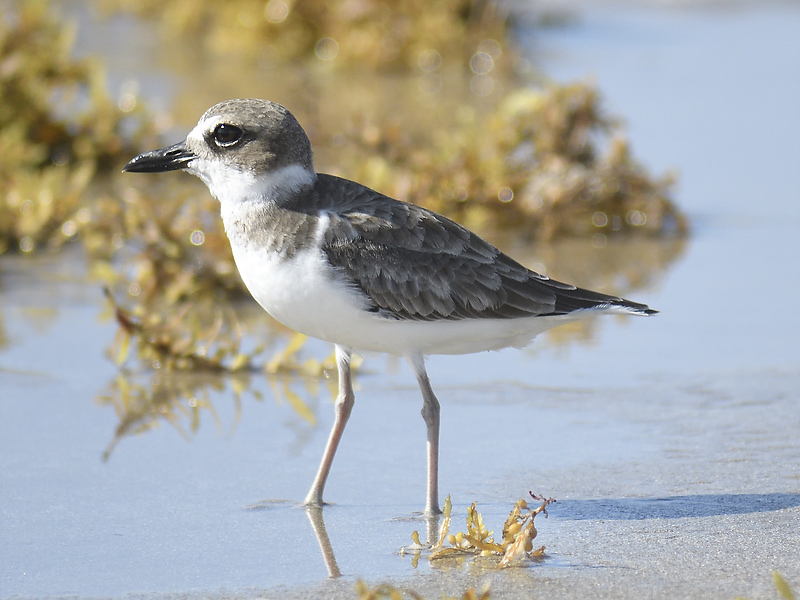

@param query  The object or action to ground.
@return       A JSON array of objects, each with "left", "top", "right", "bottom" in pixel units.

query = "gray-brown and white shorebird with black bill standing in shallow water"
[{"left": 123, "top": 99, "right": 656, "bottom": 515}]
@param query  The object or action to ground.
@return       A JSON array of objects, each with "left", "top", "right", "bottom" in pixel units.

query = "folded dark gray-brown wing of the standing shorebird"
[{"left": 318, "top": 178, "right": 641, "bottom": 320}]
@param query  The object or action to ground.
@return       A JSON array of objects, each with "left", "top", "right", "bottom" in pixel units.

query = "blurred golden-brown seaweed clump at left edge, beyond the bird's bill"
[{"left": 0, "top": 0, "right": 148, "bottom": 253}]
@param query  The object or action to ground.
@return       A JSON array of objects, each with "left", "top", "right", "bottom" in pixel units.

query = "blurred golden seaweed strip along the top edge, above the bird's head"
[{"left": 98, "top": 0, "right": 508, "bottom": 70}]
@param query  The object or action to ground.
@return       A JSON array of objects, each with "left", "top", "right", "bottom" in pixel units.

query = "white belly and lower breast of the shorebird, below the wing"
[{"left": 228, "top": 248, "right": 583, "bottom": 355}]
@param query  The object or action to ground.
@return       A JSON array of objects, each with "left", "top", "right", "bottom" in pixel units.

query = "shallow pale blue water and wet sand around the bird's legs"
[{"left": 0, "top": 4, "right": 800, "bottom": 598}]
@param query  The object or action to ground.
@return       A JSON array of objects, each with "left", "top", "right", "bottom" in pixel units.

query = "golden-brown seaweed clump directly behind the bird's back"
[{"left": 338, "top": 84, "right": 688, "bottom": 241}]
